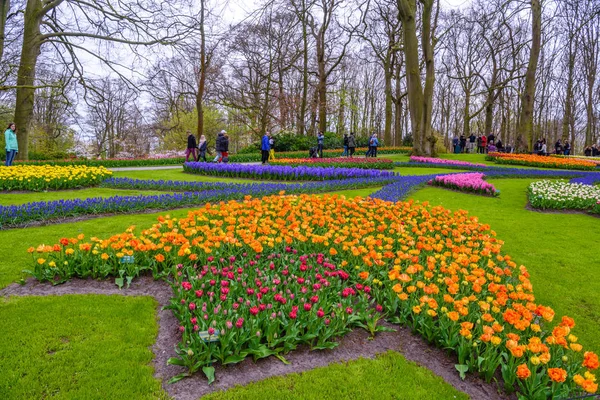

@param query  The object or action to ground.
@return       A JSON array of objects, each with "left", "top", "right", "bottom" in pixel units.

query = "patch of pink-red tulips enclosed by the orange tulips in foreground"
[{"left": 169, "top": 252, "right": 387, "bottom": 383}]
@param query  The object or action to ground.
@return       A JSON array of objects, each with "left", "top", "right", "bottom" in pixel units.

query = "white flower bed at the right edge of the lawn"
[{"left": 527, "top": 180, "right": 600, "bottom": 210}]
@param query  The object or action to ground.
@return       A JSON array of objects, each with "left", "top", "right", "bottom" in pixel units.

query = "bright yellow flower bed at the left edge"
[{"left": 0, "top": 165, "right": 112, "bottom": 192}]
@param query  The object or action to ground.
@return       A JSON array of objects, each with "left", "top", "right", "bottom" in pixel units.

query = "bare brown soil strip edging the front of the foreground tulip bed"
[{"left": 0, "top": 276, "right": 516, "bottom": 400}]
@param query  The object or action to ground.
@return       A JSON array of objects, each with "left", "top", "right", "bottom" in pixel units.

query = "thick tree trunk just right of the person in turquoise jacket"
[{"left": 14, "top": 0, "right": 42, "bottom": 160}]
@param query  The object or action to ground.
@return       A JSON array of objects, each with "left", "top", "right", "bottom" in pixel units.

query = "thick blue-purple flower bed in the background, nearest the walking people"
[{"left": 183, "top": 162, "right": 395, "bottom": 181}]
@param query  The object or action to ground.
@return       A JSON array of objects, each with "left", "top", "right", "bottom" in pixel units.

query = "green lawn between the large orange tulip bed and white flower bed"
[{"left": 410, "top": 179, "right": 600, "bottom": 352}]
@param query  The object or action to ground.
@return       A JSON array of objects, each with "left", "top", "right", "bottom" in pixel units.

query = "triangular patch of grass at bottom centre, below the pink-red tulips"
[{"left": 203, "top": 352, "right": 468, "bottom": 400}]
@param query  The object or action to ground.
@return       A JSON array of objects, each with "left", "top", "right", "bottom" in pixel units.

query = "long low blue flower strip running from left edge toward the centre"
[{"left": 0, "top": 176, "right": 401, "bottom": 229}]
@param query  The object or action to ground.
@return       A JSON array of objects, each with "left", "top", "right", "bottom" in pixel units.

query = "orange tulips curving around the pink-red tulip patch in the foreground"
[{"left": 29, "top": 195, "right": 599, "bottom": 398}]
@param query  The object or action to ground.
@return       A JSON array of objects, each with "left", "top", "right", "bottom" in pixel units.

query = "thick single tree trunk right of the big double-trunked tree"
[{"left": 516, "top": 0, "right": 542, "bottom": 152}]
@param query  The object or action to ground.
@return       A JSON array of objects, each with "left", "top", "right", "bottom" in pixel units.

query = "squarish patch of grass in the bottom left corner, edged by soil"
[{"left": 0, "top": 295, "right": 167, "bottom": 400}]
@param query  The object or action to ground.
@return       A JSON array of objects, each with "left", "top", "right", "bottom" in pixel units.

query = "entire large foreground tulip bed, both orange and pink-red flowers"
[{"left": 29, "top": 195, "right": 599, "bottom": 399}]
